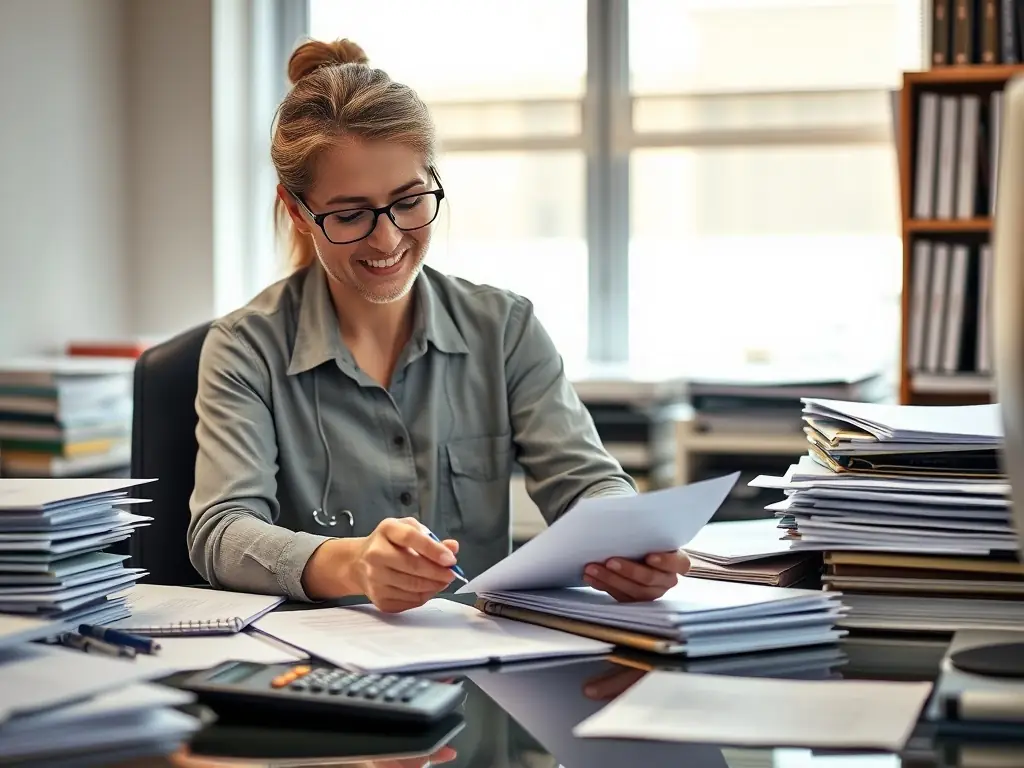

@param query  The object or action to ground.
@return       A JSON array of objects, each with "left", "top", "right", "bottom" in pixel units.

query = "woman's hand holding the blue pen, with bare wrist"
[{"left": 303, "top": 517, "right": 459, "bottom": 613}]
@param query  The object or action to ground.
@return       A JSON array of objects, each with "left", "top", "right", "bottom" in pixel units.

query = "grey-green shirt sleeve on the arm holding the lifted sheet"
[{"left": 505, "top": 298, "right": 636, "bottom": 524}]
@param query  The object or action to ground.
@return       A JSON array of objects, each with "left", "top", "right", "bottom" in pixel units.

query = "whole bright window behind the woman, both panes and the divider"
[{"left": 301, "top": 0, "right": 924, "bottom": 371}]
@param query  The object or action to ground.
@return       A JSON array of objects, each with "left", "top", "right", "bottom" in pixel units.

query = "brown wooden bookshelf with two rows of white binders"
[{"left": 897, "top": 63, "right": 1024, "bottom": 404}]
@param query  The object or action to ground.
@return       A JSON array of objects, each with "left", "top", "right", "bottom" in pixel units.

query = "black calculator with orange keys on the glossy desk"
[{"left": 178, "top": 662, "right": 465, "bottom": 724}]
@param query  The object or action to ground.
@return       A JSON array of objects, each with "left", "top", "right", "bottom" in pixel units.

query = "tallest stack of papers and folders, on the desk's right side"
[{"left": 753, "top": 399, "right": 1024, "bottom": 633}]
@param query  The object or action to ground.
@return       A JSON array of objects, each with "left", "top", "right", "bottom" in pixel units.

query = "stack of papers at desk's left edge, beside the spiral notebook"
[{"left": 0, "top": 478, "right": 153, "bottom": 627}]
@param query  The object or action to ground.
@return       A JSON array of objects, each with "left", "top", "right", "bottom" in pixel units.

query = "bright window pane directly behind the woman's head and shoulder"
[{"left": 309, "top": 0, "right": 588, "bottom": 359}]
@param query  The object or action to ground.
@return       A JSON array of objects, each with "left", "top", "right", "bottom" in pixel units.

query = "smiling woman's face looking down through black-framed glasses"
[{"left": 293, "top": 139, "right": 437, "bottom": 304}]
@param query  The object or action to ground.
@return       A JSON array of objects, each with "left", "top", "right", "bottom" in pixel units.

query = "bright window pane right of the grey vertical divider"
[{"left": 628, "top": 0, "right": 922, "bottom": 370}]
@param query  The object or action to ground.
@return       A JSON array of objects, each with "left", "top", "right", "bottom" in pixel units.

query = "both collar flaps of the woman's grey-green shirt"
[{"left": 288, "top": 264, "right": 469, "bottom": 376}]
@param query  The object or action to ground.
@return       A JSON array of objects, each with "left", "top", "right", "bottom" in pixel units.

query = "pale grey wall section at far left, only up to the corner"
[{"left": 0, "top": 0, "right": 132, "bottom": 357}]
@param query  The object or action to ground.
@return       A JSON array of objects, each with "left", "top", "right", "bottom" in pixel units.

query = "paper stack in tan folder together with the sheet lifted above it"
[{"left": 444, "top": 474, "right": 841, "bottom": 656}]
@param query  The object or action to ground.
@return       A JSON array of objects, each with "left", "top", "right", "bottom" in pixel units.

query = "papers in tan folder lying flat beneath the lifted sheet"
[{"left": 476, "top": 578, "right": 845, "bottom": 658}]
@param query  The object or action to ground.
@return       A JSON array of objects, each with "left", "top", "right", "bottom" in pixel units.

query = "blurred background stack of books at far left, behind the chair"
[{"left": 0, "top": 356, "right": 134, "bottom": 477}]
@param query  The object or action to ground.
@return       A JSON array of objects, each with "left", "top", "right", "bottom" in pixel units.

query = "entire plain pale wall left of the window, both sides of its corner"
[{"left": 0, "top": 0, "right": 221, "bottom": 359}]
